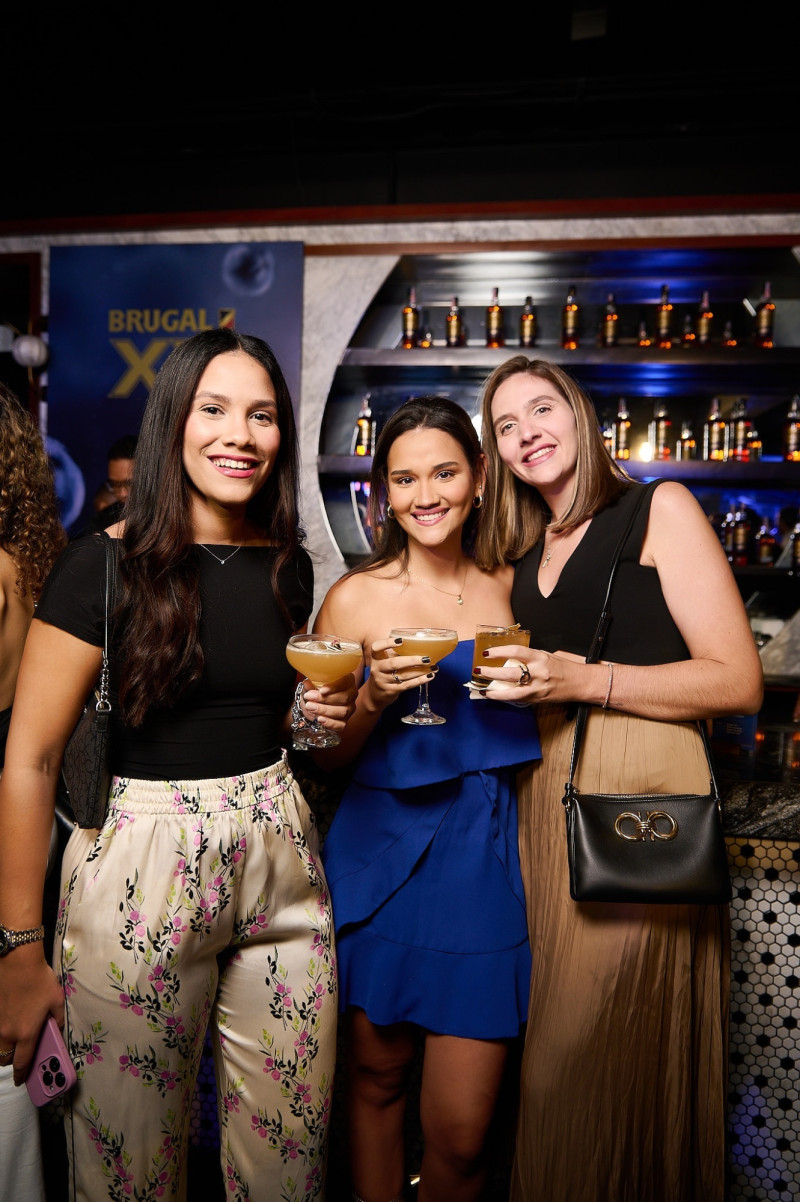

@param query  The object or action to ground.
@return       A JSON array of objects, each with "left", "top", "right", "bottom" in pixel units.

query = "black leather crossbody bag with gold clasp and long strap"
[{"left": 562, "top": 484, "right": 732, "bottom": 905}]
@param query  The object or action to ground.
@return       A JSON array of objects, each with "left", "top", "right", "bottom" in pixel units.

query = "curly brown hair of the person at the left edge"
[{"left": 0, "top": 383, "right": 66, "bottom": 601}]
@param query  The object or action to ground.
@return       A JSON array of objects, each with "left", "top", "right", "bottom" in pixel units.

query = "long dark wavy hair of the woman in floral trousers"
[{"left": 117, "top": 328, "right": 303, "bottom": 726}]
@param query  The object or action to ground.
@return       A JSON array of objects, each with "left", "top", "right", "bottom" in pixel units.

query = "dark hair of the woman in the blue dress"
[{"left": 347, "top": 394, "right": 483, "bottom": 576}]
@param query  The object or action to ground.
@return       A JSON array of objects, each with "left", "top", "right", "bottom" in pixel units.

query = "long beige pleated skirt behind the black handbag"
[{"left": 511, "top": 707, "right": 730, "bottom": 1202}]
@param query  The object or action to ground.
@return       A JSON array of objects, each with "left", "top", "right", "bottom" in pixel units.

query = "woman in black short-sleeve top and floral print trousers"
[{"left": 0, "top": 328, "right": 356, "bottom": 1202}]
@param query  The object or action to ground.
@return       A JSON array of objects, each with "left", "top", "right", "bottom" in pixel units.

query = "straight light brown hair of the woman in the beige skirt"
[{"left": 477, "top": 355, "right": 633, "bottom": 564}]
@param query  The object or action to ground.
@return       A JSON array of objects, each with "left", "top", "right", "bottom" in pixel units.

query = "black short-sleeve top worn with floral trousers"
[{"left": 36, "top": 535, "right": 314, "bottom": 780}]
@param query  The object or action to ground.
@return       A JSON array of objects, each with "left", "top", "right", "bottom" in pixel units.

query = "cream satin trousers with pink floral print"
[{"left": 54, "top": 757, "right": 336, "bottom": 1202}]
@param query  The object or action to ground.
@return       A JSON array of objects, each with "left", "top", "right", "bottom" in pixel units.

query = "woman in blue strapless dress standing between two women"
[{"left": 315, "top": 397, "right": 539, "bottom": 1202}]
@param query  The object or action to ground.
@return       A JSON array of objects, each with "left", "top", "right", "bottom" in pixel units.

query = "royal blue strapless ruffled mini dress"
[{"left": 323, "top": 641, "right": 541, "bottom": 1039}]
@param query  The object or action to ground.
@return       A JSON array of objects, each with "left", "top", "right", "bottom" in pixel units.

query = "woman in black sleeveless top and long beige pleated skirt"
[{"left": 479, "top": 355, "right": 763, "bottom": 1202}]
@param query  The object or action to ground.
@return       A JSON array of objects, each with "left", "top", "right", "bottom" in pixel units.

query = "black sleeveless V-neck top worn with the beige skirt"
[{"left": 512, "top": 483, "right": 691, "bottom": 665}]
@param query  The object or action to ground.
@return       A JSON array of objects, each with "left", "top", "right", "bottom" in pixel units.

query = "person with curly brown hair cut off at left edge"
[{"left": 0, "top": 383, "right": 66, "bottom": 1202}]
